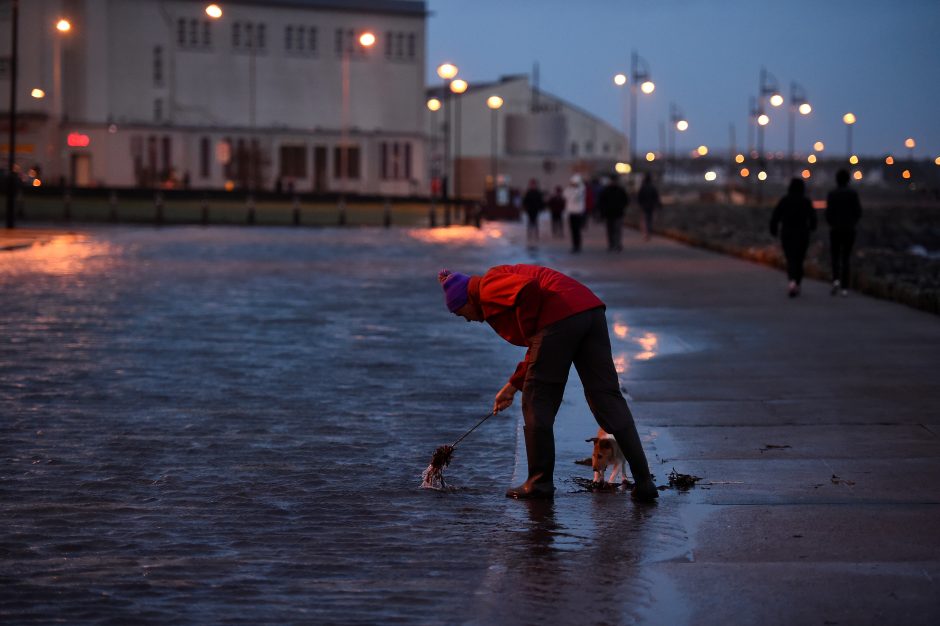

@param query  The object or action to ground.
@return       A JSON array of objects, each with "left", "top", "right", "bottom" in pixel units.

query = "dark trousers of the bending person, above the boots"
[{"left": 522, "top": 307, "right": 636, "bottom": 433}]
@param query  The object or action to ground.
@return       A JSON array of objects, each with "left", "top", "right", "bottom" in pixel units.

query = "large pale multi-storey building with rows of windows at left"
[{"left": 0, "top": 0, "right": 427, "bottom": 195}]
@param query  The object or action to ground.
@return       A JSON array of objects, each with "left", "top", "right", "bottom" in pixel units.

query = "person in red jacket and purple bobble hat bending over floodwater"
[{"left": 438, "top": 264, "right": 659, "bottom": 501}]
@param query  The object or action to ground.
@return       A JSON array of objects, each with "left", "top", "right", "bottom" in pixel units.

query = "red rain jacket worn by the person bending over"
[{"left": 467, "top": 264, "right": 604, "bottom": 390}]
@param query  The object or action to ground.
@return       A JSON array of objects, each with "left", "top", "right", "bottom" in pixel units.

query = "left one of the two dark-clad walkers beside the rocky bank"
[{"left": 770, "top": 178, "right": 816, "bottom": 298}]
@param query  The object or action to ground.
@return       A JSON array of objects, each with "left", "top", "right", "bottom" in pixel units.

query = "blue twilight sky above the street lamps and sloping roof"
[{"left": 427, "top": 0, "right": 940, "bottom": 158}]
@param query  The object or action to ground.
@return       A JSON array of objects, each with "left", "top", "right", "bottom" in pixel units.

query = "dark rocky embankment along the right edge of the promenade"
[{"left": 627, "top": 199, "right": 940, "bottom": 314}]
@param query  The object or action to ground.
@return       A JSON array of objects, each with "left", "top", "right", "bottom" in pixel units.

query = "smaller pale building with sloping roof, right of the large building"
[{"left": 428, "top": 74, "right": 629, "bottom": 198}]
